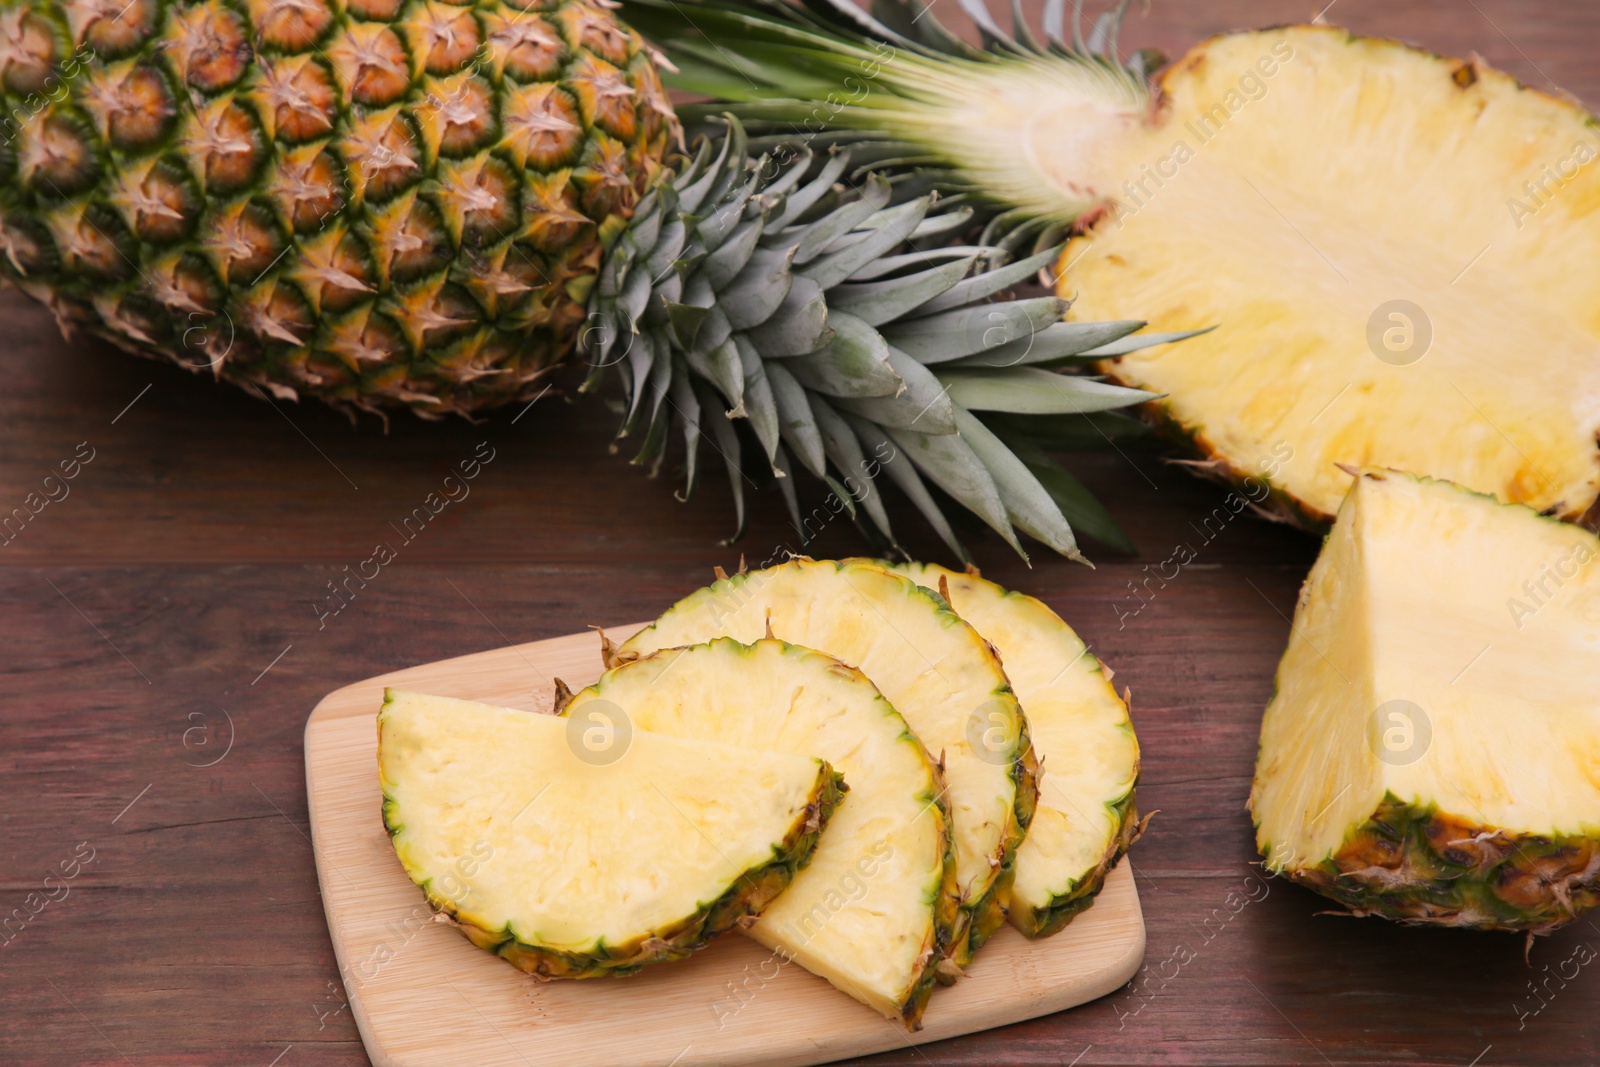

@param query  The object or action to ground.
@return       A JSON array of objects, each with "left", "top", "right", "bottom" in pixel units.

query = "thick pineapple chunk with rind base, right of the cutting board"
[{"left": 1250, "top": 470, "right": 1600, "bottom": 933}]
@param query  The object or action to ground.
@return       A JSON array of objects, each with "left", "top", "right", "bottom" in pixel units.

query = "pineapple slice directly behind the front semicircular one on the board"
[{"left": 562, "top": 638, "right": 960, "bottom": 1030}]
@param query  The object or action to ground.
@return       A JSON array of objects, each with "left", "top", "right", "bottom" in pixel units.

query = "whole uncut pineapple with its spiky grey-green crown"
[{"left": 0, "top": 0, "right": 1184, "bottom": 558}]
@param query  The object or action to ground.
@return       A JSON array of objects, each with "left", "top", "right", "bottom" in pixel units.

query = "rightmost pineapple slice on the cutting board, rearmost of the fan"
[{"left": 880, "top": 563, "right": 1139, "bottom": 937}]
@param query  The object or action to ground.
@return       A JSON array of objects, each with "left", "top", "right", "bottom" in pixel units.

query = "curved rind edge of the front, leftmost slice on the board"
[{"left": 379, "top": 689, "right": 848, "bottom": 979}]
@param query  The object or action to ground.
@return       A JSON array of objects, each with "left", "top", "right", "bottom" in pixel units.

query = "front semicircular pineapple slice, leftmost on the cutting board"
[{"left": 378, "top": 689, "right": 843, "bottom": 977}]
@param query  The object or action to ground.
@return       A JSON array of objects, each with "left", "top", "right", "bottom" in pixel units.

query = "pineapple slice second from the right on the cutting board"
[{"left": 618, "top": 558, "right": 1037, "bottom": 966}]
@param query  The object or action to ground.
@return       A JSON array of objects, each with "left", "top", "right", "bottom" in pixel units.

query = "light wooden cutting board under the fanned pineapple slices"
[{"left": 306, "top": 625, "right": 1144, "bottom": 1067}]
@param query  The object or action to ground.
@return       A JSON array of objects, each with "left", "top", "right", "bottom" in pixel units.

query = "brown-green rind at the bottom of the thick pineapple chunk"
[{"left": 1262, "top": 792, "right": 1600, "bottom": 934}]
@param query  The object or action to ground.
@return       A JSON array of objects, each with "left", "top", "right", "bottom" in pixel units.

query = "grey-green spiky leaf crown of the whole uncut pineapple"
[{"left": 582, "top": 117, "right": 1187, "bottom": 560}]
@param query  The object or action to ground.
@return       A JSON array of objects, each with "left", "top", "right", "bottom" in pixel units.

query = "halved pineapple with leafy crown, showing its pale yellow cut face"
[{"left": 636, "top": 0, "right": 1600, "bottom": 526}]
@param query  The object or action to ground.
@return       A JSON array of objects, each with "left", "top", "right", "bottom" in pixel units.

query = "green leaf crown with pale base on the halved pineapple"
[{"left": 622, "top": 0, "right": 1165, "bottom": 251}]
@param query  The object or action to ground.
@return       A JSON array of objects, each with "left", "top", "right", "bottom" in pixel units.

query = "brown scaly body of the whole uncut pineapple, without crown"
[{"left": 0, "top": 0, "right": 678, "bottom": 418}]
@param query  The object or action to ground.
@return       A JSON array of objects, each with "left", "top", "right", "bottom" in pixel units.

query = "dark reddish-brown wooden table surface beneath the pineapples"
[{"left": 0, "top": 0, "right": 1600, "bottom": 1067}]
